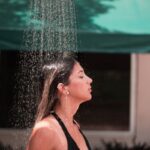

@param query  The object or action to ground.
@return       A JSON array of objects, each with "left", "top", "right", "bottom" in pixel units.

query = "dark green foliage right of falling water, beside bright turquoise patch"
[{"left": 75, "top": 0, "right": 115, "bottom": 32}]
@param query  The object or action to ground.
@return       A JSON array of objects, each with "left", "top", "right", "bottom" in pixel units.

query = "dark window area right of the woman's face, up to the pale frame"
[{"left": 77, "top": 53, "right": 130, "bottom": 131}]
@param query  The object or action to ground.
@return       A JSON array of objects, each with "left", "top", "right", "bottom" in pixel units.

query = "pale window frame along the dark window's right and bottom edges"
[{"left": 84, "top": 54, "right": 137, "bottom": 138}]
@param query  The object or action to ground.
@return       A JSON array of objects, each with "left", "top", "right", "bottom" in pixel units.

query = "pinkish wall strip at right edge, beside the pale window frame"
[{"left": 136, "top": 54, "right": 150, "bottom": 143}]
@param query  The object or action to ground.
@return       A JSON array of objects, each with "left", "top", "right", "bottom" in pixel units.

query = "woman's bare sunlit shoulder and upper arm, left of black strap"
[{"left": 28, "top": 118, "right": 58, "bottom": 150}]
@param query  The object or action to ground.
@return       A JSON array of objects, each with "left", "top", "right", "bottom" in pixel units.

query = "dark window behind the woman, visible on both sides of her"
[{"left": 0, "top": 51, "right": 130, "bottom": 131}]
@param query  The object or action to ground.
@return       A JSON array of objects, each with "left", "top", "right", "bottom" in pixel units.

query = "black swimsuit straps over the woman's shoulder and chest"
[{"left": 51, "top": 112, "right": 91, "bottom": 150}]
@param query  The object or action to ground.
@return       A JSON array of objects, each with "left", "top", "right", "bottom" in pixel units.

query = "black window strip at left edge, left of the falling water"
[{"left": 0, "top": 51, "right": 18, "bottom": 128}]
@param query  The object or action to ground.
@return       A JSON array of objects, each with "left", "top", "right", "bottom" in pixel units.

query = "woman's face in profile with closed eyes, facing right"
[{"left": 67, "top": 63, "right": 92, "bottom": 102}]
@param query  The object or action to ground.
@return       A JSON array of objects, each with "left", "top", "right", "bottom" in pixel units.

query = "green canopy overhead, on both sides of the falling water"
[{"left": 0, "top": 0, "right": 150, "bottom": 53}]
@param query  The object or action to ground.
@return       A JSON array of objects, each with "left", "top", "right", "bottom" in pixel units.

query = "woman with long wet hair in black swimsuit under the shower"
[{"left": 27, "top": 56, "right": 92, "bottom": 150}]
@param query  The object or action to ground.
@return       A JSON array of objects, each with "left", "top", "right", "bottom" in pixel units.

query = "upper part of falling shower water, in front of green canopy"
[{"left": 26, "top": 0, "right": 77, "bottom": 51}]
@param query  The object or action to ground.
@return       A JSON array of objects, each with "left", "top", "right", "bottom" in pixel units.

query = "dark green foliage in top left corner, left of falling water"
[{"left": 0, "top": 0, "right": 30, "bottom": 29}]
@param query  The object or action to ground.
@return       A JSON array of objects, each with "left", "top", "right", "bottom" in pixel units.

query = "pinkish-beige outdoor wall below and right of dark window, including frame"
[{"left": 0, "top": 54, "right": 150, "bottom": 147}]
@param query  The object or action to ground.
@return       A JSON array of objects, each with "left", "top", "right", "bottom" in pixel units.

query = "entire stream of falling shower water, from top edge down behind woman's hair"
[{"left": 12, "top": 0, "right": 77, "bottom": 131}]
